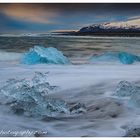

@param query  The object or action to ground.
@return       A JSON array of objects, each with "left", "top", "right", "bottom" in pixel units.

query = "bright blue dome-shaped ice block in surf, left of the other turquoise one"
[{"left": 21, "top": 46, "right": 70, "bottom": 64}]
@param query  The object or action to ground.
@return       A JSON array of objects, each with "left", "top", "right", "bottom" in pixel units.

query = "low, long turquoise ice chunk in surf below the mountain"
[{"left": 90, "top": 52, "right": 140, "bottom": 64}]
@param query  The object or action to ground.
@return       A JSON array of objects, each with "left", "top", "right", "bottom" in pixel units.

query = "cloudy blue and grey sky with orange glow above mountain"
[{"left": 0, "top": 4, "right": 140, "bottom": 33}]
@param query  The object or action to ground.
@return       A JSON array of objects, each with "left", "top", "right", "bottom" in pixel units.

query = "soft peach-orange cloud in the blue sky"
[{"left": 1, "top": 4, "right": 59, "bottom": 24}]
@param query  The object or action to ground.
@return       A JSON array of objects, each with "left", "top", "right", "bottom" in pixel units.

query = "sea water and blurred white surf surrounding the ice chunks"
[{"left": 0, "top": 36, "right": 140, "bottom": 137}]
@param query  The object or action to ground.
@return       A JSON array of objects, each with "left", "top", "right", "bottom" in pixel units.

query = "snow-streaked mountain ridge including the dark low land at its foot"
[{"left": 63, "top": 18, "right": 140, "bottom": 36}]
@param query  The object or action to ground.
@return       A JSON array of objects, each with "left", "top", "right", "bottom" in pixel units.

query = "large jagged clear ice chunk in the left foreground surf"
[{"left": 0, "top": 72, "right": 85, "bottom": 118}]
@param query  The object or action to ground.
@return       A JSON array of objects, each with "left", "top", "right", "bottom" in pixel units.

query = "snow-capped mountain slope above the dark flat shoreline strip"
[{"left": 78, "top": 19, "right": 140, "bottom": 33}]
